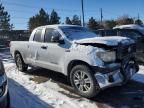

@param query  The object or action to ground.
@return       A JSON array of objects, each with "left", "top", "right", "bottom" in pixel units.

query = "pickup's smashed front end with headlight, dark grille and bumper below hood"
[{"left": 80, "top": 43, "right": 139, "bottom": 89}]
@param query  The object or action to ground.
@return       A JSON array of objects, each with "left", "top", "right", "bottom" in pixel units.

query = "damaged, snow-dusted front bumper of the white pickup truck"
[{"left": 92, "top": 59, "right": 139, "bottom": 89}]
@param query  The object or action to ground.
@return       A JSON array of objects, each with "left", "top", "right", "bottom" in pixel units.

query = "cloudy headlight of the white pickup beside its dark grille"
[{"left": 97, "top": 51, "right": 116, "bottom": 62}]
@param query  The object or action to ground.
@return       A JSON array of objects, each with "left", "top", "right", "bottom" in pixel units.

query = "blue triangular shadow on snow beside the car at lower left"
[{"left": 9, "top": 79, "right": 52, "bottom": 108}]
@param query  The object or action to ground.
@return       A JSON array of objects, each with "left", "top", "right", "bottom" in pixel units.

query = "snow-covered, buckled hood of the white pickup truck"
[{"left": 75, "top": 36, "right": 134, "bottom": 46}]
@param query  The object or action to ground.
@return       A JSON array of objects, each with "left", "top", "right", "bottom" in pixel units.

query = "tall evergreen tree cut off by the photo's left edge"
[{"left": 0, "top": 4, "right": 12, "bottom": 30}]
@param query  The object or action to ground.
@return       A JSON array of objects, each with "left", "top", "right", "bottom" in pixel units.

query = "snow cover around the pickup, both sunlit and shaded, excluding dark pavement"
[{"left": 0, "top": 48, "right": 144, "bottom": 108}]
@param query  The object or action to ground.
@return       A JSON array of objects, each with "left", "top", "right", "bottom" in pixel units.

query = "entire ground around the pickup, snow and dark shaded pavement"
[{"left": 0, "top": 49, "right": 144, "bottom": 108}]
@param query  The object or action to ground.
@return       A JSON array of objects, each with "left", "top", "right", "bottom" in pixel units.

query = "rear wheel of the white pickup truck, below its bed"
[{"left": 15, "top": 53, "right": 28, "bottom": 72}]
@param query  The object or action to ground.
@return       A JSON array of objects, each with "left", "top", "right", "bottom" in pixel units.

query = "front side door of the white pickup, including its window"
[{"left": 40, "top": 28, "right": 65, "bottom": 72}]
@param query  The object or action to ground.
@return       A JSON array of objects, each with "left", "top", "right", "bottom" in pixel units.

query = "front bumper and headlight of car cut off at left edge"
[{"left": 0, "top": 75, "right": 9, "bottom": 108}]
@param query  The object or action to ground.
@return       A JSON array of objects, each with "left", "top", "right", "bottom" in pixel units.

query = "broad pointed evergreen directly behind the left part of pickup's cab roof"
[{"left": 28, "top": 8, "right": 50, "bottom": 31}]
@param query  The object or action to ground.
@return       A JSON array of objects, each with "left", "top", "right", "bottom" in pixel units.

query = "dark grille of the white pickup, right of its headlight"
[{"left": 117, "top": 44, "right": 136, "bottom": 60}]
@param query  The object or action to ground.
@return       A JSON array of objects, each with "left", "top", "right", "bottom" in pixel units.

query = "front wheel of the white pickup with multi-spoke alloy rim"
[{"left": 70, "top": 65, "right": 100, "bottom": 98}]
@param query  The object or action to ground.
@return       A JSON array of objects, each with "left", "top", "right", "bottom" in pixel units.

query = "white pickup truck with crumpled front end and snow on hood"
[{"left": 10, "top": 25, "right": 139, "bottom": 98}]
